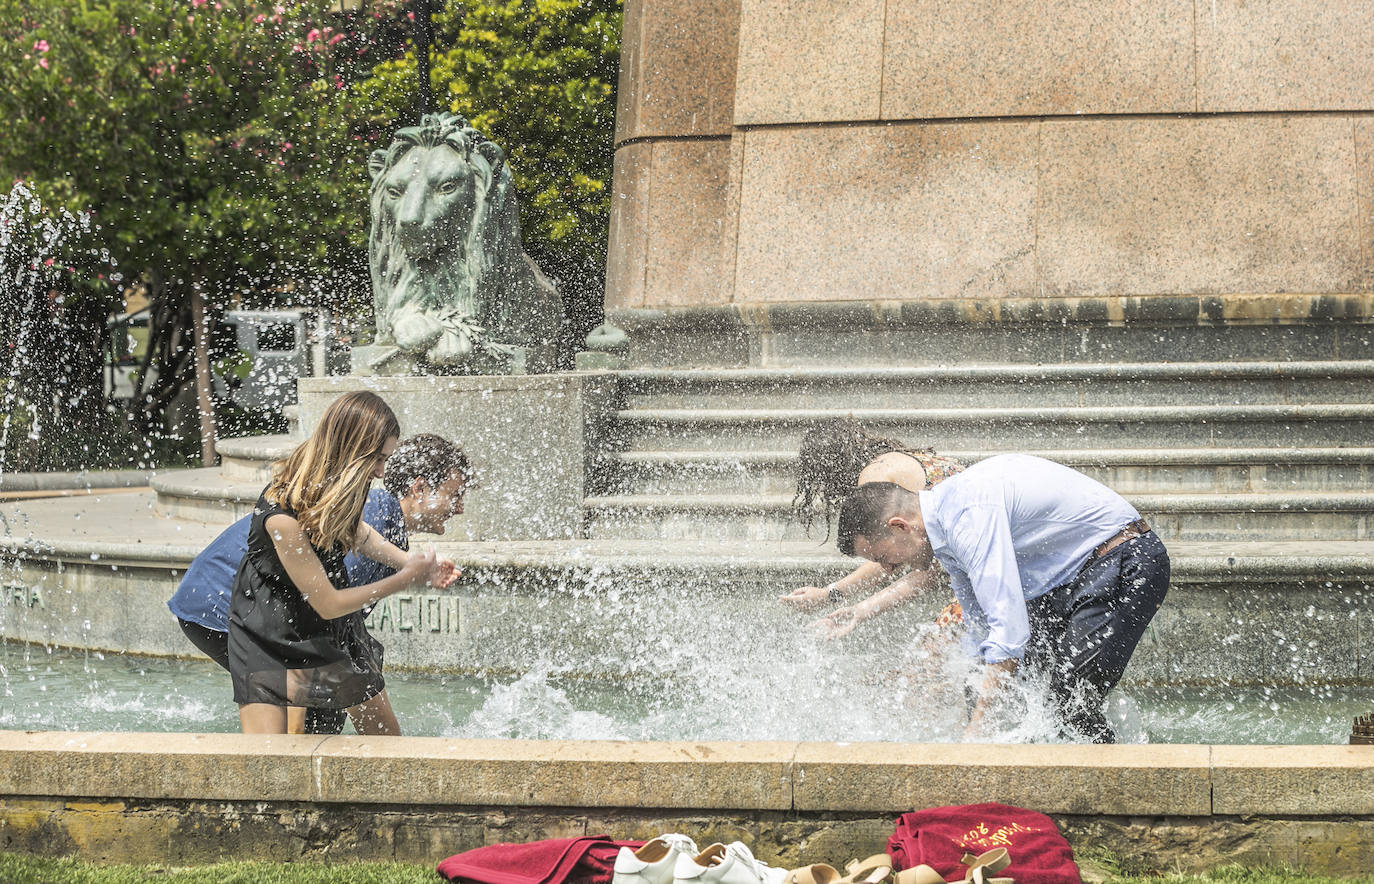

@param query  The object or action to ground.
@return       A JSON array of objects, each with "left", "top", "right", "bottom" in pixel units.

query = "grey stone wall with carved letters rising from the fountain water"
[{"left": 0, "top": 508, "right": 1374, "bottom": 686}]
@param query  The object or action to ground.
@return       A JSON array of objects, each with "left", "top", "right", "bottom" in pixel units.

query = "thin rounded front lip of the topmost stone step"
[{"left": 614, "top": 359, "right": 1374, "bottom": 392}]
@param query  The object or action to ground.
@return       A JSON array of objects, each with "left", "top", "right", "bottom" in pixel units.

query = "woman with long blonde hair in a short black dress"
[{"left": 229, "top": 392, "right": 458, "bottom": 734}]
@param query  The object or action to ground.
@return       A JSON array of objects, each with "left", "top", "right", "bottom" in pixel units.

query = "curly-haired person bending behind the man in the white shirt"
[{"left": 780, "top": 417, "right": 963, "bottom": 638}]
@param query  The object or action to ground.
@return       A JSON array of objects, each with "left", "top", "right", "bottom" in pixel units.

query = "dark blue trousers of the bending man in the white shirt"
[{"left": 1025, "top": 531, "right": 1169, "bottom": 742}]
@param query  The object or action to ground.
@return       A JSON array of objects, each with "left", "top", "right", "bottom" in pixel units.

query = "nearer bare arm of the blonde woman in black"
[{"left": 267, "top": 514, "right": 442, "bottom": 620}]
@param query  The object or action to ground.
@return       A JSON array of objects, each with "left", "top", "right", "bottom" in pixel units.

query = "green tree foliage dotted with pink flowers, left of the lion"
[{"left": 0, "top": 0, "right": 401, "bottom": 305}]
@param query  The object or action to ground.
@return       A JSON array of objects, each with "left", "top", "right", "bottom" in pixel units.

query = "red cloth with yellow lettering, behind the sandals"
[{"left": 888, "top": 804, "right": 1083, "bottom": 884}]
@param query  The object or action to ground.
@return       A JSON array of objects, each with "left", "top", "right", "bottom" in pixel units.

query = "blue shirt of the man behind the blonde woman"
[{"left": 168, "top": 488, "right": 409, "bottom": 632}]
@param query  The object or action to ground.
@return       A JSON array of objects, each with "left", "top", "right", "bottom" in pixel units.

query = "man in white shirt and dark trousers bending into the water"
[{"left": 837, "top": 454, "right": 1169, "bottom": 742}]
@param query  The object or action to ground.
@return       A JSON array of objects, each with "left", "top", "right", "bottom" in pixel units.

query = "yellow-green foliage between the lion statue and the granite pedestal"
[{"left": 353, "top": 0, "right": 621, "bottom": 327}]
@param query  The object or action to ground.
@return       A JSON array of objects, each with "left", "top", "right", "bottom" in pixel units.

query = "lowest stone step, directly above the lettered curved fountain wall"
[{"left": 584, "top": 491, "right": 1374, "bottom": 543}]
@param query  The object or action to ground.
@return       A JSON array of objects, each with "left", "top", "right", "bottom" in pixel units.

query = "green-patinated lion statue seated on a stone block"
[{"left": 368, "top": 113, "right": 563, "bottom": 371}]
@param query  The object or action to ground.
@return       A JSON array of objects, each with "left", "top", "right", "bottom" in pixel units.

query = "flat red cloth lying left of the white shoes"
[{"left": 438, "top": 835, "right": 644, "bottom": 884}]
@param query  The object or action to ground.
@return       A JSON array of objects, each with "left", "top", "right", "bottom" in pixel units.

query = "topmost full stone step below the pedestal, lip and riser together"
[{"left": 617, "top": 360, "right": 1374, "bottom": 408}]
